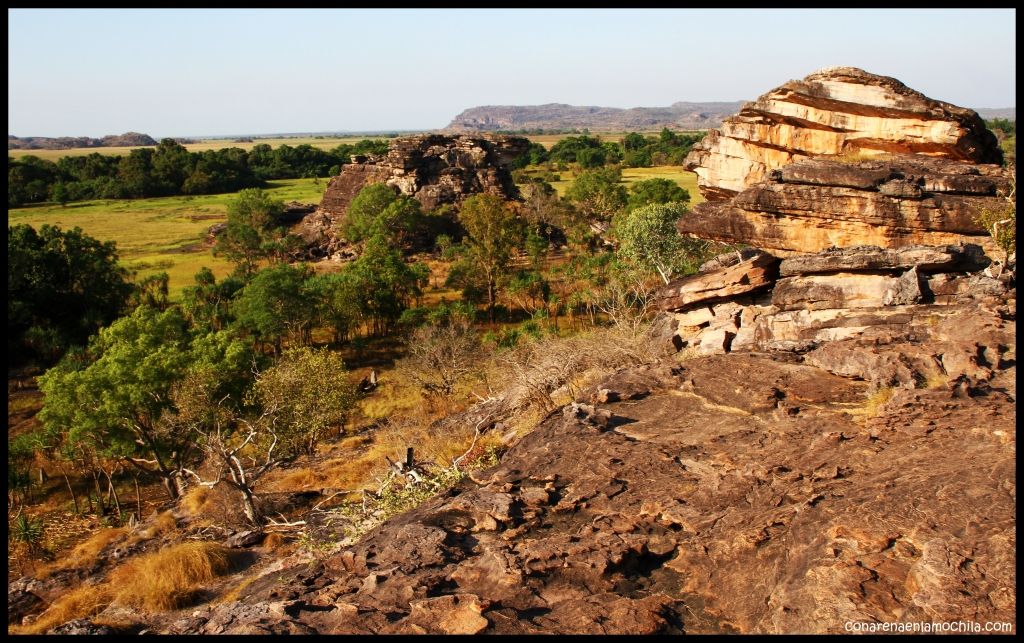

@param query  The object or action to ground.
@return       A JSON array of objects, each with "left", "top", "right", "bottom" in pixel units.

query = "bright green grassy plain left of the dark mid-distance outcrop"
[{"left": 7, "top": 178, "right": 327, "bottom": 298}]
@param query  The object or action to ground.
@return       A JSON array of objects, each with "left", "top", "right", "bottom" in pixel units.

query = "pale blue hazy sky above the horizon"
[{"left": 7, "top": 9, "right": 1017, "bottom": 138}]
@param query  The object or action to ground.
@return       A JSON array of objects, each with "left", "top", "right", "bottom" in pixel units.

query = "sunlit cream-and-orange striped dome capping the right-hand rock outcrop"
[{"left": 686, "top": 67, "right": 1002, "bottom": 201}]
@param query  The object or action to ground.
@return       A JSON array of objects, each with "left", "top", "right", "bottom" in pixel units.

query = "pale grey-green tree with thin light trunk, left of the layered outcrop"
[{"left": 615, "top": 203, "right": 686, "bottom": 284}]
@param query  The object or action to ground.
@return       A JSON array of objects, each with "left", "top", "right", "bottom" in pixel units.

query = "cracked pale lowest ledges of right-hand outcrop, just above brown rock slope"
[{"left": 658, "top": 246, "right": 1016, "bottom": 366}]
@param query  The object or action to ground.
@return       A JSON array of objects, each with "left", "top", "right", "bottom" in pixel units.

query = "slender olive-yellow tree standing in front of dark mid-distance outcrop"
[{"left": 459, "top": 195, "right": 523, "bottom": 322}]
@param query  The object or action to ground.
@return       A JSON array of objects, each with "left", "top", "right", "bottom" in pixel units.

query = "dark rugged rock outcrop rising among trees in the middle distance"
[{"left": 295, "top": 134, "right": 529, "bottom": 256}]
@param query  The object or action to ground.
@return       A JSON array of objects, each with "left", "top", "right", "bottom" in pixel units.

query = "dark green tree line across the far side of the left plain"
[{"left": 7, "top": 138, "right": 388, "bottom": 208}]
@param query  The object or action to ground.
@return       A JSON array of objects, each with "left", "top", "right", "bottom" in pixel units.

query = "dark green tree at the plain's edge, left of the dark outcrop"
[{"left": 215, "top": 188, "right": 287, "bottom": 273}]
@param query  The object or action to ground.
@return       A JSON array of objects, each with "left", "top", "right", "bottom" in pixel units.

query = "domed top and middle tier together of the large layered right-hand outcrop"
[{"left": 679, "top": 68, "right": 1014, "bottom": 255}]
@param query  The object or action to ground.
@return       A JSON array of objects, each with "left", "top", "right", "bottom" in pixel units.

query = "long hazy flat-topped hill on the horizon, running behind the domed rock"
[{"left": 445, "top": 100, "right": 1017, "bottom": 132}]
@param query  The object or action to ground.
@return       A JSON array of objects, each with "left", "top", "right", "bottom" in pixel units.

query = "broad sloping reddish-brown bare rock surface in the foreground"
[{"left": 176, "top": 322, "right": 1016, "bottom": 634}]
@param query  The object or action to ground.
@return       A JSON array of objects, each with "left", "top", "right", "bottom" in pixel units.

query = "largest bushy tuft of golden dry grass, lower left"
[{"left": 111, "top": 543, "right": 231, "bottom": 611}]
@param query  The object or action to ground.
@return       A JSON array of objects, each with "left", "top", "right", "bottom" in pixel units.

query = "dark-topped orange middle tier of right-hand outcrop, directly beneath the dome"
[{"left": 679, "top": 156, "right": 1012, "bottom": 254}]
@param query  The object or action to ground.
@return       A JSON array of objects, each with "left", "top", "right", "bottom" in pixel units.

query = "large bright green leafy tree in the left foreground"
[{"left": 39, "top": 306, "right": 247, "bottom": 499}]
